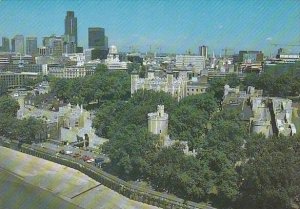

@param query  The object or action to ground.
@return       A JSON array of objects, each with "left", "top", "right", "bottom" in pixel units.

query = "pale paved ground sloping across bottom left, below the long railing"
[{"left": 0, "top": 146, "right": 161, "bottom": 209}]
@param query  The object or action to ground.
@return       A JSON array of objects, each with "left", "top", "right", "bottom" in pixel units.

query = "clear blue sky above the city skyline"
[{"left": 0, "top": 0, "right": 300, "bottom": 54}]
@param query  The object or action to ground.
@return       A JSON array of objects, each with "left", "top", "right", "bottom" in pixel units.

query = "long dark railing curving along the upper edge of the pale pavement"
[{"left": 0, "top": 140, "right": 215, "bottom": 209}]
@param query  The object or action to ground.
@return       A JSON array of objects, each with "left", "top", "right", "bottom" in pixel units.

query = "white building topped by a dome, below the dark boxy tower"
[{"left": 105, "top": 45, "right": 127, "bottom": 70}]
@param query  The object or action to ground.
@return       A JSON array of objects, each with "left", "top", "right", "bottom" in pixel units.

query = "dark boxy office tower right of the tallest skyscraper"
[{"left": 88, "top": 27, "right": 108, "bottom": 60}]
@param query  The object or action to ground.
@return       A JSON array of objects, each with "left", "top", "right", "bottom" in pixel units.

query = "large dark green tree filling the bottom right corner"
[{"left": 236, "top": 135, "right": 300, "bottom": 209}]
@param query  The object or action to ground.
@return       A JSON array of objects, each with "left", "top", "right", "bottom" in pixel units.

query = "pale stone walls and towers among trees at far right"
[{"left": 222, "top": 85, "right": 296, "bottom": 137}]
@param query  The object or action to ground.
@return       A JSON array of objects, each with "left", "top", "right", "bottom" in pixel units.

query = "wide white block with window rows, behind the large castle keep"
[{"left": 176, "top": 55, "right": 205, "bottom": 76}]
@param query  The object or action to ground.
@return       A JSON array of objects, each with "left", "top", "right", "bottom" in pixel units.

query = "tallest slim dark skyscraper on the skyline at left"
[{"left": 65, "top": 11, "right": 78, "bottom": 53}]
